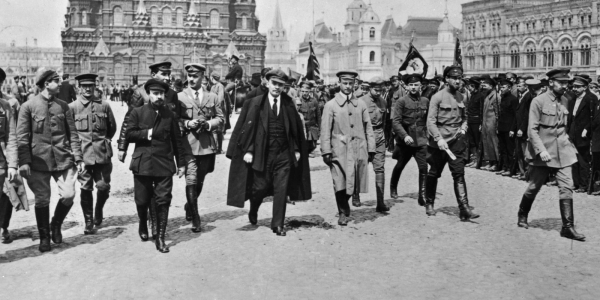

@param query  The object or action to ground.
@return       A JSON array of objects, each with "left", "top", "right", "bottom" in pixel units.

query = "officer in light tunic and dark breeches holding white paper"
[{"left": 425, "top": 66, "right": 479, "bottom": 221}]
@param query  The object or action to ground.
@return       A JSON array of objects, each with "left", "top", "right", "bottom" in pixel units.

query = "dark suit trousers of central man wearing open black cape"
[{"left": 250, "top": 149, "right": 292, "bottom": 228}]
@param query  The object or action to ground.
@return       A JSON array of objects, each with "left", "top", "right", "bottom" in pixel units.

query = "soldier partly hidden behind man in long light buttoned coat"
[{"left": 352, "top": 77, "right": 389, "bottom": 212}]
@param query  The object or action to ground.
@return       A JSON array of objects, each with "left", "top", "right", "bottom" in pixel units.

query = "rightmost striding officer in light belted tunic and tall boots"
[{"left": 517, "top": 69, "right": 585, "bottom": 241}]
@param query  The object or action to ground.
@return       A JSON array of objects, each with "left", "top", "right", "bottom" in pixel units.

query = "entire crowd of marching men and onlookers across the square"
[{"left": 0, "top": 56, "right": 600, "bottom": 253}]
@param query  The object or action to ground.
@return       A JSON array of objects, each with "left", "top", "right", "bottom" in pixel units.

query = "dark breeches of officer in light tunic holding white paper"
[{"left": 427, "top": 136, "right": 467, "bottom": 179}]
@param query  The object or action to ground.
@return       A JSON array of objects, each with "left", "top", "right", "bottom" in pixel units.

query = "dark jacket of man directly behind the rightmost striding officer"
[{"left": 567, "top": 90, "right": 598, "bottom": 151}]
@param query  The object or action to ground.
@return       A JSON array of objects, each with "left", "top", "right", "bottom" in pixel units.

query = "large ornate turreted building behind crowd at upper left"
[{"left": 61, "top": 0, "right": 266, "bottom": 83}]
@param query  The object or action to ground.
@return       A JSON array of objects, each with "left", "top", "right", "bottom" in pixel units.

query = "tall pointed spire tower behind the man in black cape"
[{"left": 265, "top": 0, "right": 296, "bottom": 72}]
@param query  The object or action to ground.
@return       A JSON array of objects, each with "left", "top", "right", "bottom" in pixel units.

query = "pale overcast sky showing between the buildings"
[{"left": 0, "top": 0, "right": 472, "bottom": 48}]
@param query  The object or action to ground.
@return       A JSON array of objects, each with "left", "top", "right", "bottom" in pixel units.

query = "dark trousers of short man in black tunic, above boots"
[{"left": 133, "top": 175, "right": 173, "bottom": 206}]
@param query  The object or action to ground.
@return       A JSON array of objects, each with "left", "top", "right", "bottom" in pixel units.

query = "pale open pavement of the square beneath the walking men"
[{"left": 0, "top": 103, "right": 600, "bottom": 299}]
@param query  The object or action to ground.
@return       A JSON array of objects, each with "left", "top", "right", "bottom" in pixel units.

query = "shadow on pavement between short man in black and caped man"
[{"left": 166, "top": 209, "right": 248, "bottom": 248}]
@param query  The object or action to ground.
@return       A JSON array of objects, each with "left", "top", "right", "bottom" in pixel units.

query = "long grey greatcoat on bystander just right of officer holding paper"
[{"left": 481, "top": 91, "right": 500, "bottom": 160}]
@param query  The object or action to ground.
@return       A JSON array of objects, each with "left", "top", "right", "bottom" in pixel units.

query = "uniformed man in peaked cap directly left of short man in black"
[{"left": 69, "top": 74, "right": 117, "bottom": 234}]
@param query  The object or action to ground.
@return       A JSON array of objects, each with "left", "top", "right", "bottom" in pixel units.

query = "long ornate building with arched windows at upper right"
[{"left": 462, "top": 0, "right": 600, "bottom": 77}]
